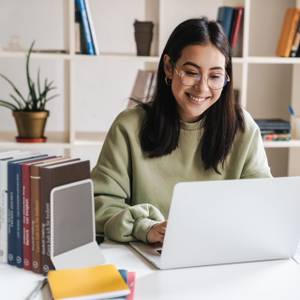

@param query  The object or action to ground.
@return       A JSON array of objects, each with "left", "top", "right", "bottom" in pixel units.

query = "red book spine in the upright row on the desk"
[{"left": 22, "top": 165, "right": 32, "bottom": 270}]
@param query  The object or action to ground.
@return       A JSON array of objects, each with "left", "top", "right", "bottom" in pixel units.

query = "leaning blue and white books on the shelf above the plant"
[{"left": 75, "top": 0, "right": 99, "bottom": 55}]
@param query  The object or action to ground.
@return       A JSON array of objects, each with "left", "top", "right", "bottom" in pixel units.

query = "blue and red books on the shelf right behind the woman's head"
[{"left": 217, "top": 6, "right": 244, "bottom": 56}]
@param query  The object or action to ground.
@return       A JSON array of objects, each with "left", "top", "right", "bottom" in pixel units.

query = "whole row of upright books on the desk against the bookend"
[{"left": 0, "top": 151, "right": 90, "bottom": 274}]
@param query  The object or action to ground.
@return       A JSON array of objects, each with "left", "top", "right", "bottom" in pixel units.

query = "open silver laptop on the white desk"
[{"left": 130, "top": 177, "right": 300, "bottom": 269}]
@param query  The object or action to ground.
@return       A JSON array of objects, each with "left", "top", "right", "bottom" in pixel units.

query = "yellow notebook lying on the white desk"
[{"left": 48, "top": 265, "right": 130, "bottom": 299}]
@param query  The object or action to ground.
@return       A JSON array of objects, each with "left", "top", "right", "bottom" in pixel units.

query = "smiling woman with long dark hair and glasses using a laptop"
[{"left": 92, "top": 18, "right": 271, "bottom": 243}]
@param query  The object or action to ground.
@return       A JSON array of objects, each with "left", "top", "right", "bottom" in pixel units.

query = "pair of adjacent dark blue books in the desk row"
[{"left": 7, "top": 154, "right": 47, "bottom": 268}]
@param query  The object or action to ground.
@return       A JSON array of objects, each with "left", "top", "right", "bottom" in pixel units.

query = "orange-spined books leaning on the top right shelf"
[{"left": 276, "top": 7, "right": 300, "bottom": 57}]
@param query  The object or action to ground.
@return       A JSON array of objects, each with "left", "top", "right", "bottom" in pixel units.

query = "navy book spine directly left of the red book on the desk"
[{"left": 14, "top": 164, "right": 23, "bottom": 268}]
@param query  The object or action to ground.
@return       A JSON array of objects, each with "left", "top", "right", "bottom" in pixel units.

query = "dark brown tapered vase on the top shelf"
[{"left": 133, "top": 20, "right": 154, "bottom": 56}]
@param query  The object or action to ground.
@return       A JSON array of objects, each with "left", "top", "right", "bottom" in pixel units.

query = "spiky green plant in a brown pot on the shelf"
[{"left": 0, "top": 42, "right": 58, "bottom": 142}]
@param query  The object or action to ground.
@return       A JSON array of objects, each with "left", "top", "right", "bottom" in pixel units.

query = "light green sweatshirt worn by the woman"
[{"left": 92, "top": 107, "right": 271, "bottom": 242}]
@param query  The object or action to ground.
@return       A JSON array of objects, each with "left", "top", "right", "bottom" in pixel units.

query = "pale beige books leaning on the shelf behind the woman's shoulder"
[{"left": 127, "top": 70, "right": 157, "bottom": 107}]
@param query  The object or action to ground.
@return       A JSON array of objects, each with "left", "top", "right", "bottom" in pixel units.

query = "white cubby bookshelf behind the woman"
[{"left": 0, "top": 0, "right": 300, "bottom": 176}]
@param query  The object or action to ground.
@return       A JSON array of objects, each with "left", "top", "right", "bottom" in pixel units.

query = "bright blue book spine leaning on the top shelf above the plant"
[{"left": 75, "top": 0, "right": 96, "bottom": 55}]
